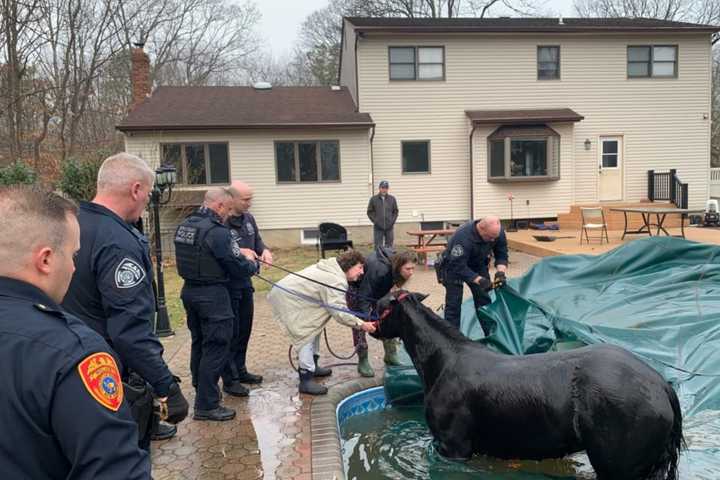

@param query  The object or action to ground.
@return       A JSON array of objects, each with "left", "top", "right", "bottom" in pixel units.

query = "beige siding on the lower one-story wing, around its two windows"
[{"left": 125, "top": 129, "right": 371, "bottom": 231}]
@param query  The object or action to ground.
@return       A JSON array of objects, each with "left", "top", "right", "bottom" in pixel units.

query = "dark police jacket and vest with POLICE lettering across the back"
[{"left": 175, "top": 207, "right": 258, "bottom": 285}]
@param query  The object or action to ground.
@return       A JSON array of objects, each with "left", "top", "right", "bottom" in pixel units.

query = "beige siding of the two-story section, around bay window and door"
[{"left": 358, "top": 34, "right": 710, "bottom": 216}]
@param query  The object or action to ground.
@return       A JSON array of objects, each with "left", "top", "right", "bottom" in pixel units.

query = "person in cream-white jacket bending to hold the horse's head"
[{"left": 268, "top": 250, "right": 375, "bottom": 395}]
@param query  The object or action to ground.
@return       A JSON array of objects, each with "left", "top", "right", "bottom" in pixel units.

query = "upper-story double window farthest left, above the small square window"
[{"left": 388, "top": 47, "right": 445, "bottom": 80}]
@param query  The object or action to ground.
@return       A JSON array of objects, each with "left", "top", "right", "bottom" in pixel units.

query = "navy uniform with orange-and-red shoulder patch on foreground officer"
[{"left": 0, "top": 277, "right": 150, "bottom": 480}]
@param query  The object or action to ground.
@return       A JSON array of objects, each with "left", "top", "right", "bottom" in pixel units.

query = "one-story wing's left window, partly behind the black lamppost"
[{"left": 160, "top": 143, "right": 230, "bottom": 185}]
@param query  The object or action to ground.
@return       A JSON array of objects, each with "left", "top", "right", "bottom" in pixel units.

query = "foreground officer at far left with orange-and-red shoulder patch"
[{"left": 0, "top": 186, "right": 150, "bottom": 480}]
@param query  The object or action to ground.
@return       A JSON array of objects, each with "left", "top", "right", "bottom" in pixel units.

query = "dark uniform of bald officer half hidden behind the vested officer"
[{"left": 223, "top": 212, "right": 267, "bottom": 383}]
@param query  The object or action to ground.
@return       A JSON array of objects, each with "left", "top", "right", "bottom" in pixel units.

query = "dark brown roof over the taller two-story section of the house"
[{"left": 346, "top": 17, "right": 720, "bottom": 33}]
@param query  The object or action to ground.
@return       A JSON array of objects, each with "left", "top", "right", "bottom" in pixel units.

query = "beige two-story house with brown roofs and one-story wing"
[{"left": 118, "top": 18, "right": 718, "bottom": 244}]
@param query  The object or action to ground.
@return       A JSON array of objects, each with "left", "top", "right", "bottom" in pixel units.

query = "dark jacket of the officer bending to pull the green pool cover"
[{"left": 444, "top": 221, "right": 508, "bottom": 283}]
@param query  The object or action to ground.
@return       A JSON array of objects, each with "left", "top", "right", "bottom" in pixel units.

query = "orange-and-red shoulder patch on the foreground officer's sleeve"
[{"left": 78, "top": 352, "right": 123, "bottom": 412}]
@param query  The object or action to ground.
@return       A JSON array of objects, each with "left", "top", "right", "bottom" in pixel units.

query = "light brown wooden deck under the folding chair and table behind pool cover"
[{"left": 506, "top": 226, "right": 720, "bottom": 257}]
